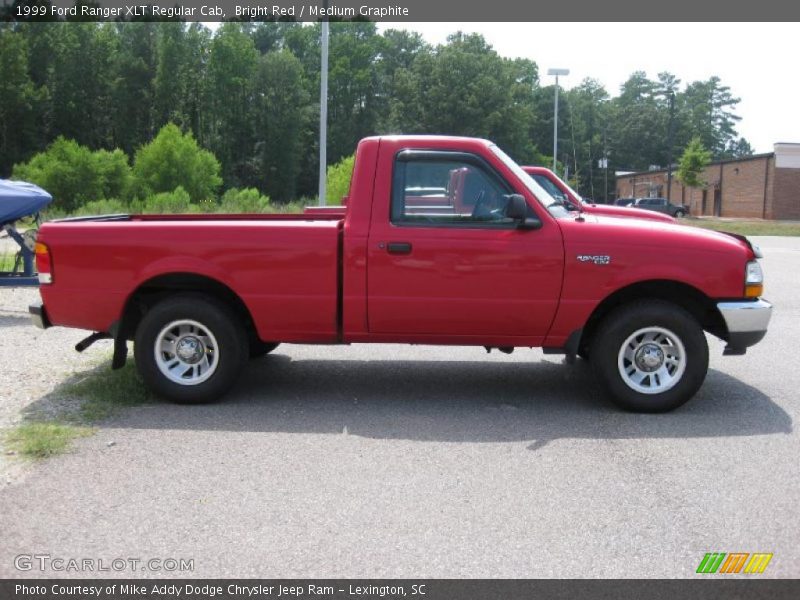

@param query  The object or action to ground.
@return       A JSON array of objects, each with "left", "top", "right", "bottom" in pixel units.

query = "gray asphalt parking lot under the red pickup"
[{"left": 0, "top": 238, "right": 800, "bottom": 578}]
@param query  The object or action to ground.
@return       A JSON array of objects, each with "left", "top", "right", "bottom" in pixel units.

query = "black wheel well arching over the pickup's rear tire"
[{"left": 119, "top": 273, "right": 258, "bottom": 341}]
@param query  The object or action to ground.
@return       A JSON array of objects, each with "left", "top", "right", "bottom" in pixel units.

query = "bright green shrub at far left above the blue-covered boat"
[{"left": 13, "top": 137, "right": 131, "bottom": 212}]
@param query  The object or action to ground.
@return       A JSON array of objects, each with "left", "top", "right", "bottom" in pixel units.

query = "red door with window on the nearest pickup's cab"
[{"left": 367, "top": 150, "right": 563, "bottom": 345}]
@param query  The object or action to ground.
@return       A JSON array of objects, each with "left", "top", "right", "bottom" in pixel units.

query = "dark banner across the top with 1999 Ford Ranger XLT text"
[{"left": 0, "top": 0, "right": 800, "bottom": 22}]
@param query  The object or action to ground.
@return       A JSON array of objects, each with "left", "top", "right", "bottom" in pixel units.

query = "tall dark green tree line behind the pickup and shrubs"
[{"left": 0, "top": 21, "right": 752, "bottom": 202}]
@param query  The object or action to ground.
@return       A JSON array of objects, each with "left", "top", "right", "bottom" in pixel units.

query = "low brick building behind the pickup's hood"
[{"left": 616, "top": 143, "right": 800, "bottom": 220}]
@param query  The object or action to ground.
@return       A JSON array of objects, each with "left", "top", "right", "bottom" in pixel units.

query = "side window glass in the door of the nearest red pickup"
[{"left": 392, "top": 158, "right": 514, "bottom": 227}]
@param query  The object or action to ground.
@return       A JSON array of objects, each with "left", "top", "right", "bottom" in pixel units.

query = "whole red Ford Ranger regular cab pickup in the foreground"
[{"left": 30, "top": 136, "right": 771, "bottom": 412}]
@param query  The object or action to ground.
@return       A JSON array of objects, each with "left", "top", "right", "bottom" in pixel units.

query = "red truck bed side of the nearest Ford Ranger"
[{"left": 39, "top": 214, "right": 342, "bottom": 342}]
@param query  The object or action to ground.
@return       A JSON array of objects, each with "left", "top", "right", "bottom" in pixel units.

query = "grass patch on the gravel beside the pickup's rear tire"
[{"left": 5, "top": 357, "right": 154, "bottom": 459}]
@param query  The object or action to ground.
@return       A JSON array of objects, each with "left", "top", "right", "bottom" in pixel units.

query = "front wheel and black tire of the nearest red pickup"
[{"left": 591, "top": 300, "right": 708, "bottom": 413}]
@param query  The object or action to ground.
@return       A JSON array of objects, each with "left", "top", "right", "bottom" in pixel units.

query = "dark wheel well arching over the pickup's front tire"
[{"left": 580, "top": 280, "right": 728, "bottom": 349}]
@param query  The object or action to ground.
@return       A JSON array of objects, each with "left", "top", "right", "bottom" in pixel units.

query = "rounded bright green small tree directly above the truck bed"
[{"left": 133, "top": 123, "right": 222, "bottom": 202}]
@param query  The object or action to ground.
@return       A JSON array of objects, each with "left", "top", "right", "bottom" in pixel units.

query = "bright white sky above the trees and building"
[{"left": 378, "top": 23, "right": 800, "bottom": 152}]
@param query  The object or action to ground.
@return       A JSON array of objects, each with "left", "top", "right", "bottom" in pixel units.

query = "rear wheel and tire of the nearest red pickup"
[{"left": 134, "top": 294, "right": 248, "bottom": 403}]
